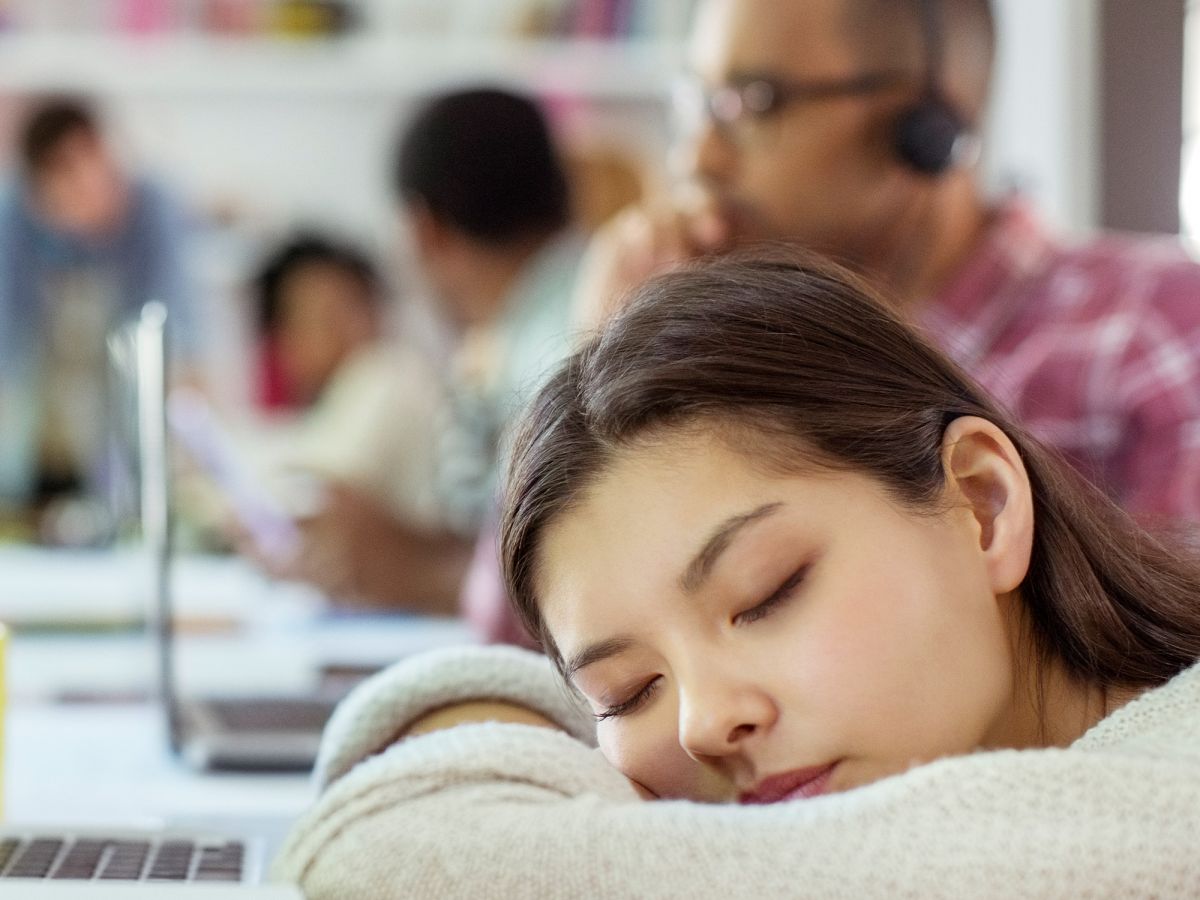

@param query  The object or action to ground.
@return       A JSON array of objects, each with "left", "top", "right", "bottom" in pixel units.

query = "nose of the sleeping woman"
[{"left": 679, "top": 673, "right": 779, "bottom": 762}]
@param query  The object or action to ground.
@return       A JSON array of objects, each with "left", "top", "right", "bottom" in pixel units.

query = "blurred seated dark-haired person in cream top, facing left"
[{"left": 235, "top": 232, "right": 466, "bottom": 561}]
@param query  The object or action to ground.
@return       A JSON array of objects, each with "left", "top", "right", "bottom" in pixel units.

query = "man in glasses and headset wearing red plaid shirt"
[{"left": 580, "top": 0, "right": 1200, "bottom": 523}]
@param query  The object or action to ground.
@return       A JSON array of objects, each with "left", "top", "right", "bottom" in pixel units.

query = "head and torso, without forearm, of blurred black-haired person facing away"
[{"left": 396, "top": 89, "right": 584, "bottom": 528}]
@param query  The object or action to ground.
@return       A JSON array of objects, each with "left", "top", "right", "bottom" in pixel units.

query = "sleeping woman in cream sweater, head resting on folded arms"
[{"left": 276, "top": 260, "right": 1200, "bottom": 900}]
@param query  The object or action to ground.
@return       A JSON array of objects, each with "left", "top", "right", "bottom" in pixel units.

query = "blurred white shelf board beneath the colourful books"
[{"left": 0, "top": 35, "right": 683, "bottom": 101}]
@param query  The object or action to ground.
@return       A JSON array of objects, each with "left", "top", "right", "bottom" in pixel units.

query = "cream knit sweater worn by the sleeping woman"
[{"left": 275, "top": 648, "right": 1200, "bottom": 900}]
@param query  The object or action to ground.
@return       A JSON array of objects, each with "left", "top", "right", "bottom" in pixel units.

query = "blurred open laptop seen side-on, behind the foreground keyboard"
[{"left": 129, "top": 302, "right": 348, "bottom": 772}]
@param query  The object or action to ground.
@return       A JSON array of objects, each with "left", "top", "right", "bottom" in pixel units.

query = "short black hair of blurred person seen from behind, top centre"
[{"left": 395, "top": 88, "right": 570, "bottom": 244}]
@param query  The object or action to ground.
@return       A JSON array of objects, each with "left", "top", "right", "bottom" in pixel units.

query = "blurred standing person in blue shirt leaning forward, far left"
[{"left": 0, "top": 98, "right": 197, "bottom": 540}]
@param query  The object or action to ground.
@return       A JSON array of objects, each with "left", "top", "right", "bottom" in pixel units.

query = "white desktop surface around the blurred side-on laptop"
[{"left": 0, "top": 548, "right": 469, "bottom": 859}]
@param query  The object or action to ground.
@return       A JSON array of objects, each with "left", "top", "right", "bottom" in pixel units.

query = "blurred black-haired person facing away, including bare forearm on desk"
[{"left": 261, "top": 89, "right": 584, "bottom": 637}]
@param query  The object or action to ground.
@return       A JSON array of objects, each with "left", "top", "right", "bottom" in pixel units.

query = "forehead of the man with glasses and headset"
[{"left": 689, "top": 0, "right": 856, "bottom": 80}]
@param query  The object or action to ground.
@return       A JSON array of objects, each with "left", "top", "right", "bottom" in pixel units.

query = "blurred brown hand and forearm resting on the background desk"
[{"left": 257, "top": 481, "right": 472, "bottom": 614}]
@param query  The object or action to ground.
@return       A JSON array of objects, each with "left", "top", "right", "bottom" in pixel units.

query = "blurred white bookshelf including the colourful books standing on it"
[{"left": 0, "top": 0, "right": 694, "bottom": 101}]
